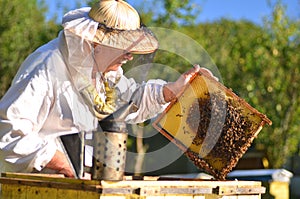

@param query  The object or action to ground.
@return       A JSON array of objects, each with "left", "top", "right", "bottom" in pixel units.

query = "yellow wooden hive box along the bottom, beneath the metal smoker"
[{"left": 0, "top": 174, "right": 265, "bottom": 199}]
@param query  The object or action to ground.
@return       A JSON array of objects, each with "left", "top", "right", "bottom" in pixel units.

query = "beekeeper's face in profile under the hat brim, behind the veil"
[{"left": 94, "top": 44, "right": 133, "bottom": 72}]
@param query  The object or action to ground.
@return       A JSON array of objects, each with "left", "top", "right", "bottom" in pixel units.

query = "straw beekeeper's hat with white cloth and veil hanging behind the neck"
[{"left": 62, "top": 0, "right": 158, "bottom": 115}]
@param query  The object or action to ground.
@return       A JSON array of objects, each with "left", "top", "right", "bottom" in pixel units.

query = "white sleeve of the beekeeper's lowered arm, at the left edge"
[{"left": 0, "top": 64, "right": 56, "bottom": 172}]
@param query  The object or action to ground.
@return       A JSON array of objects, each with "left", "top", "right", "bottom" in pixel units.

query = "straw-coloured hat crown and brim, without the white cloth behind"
[{"left": 89, "top": 0, "right": 158, "bottom": 54}]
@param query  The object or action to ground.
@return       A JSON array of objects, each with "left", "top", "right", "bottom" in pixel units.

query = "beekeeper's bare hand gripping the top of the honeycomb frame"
[{"left": 163, "top": 65, "right": 218, "bottom": 102}]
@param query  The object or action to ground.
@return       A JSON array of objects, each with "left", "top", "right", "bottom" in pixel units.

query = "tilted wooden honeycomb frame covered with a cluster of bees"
[{"left": 153, "top": 73, "right": 272, "bottom": 180}]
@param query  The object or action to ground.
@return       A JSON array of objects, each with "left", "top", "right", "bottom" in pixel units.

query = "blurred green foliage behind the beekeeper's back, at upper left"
[{"left": 0, "top": 0, "right": 57, "bottom": 97}]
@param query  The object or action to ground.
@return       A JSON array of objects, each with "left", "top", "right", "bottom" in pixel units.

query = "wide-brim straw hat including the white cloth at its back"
[{"left": 63, "top": 0, "right": 158, "bottom": 54}]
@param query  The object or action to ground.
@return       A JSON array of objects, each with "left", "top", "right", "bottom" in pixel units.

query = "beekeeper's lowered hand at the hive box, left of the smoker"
[{"left": 46, "top": 151, "right": 74, "bottom": 178}]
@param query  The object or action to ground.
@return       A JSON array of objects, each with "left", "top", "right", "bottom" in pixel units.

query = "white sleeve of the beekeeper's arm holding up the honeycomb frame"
[{"left": 117, "top": 76, "right": 168, "bottom": 123}]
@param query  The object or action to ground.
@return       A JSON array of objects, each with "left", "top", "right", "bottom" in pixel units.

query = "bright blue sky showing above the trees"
[{"left": 46, "top": 0, "right": 300, "bottom": 24}]
